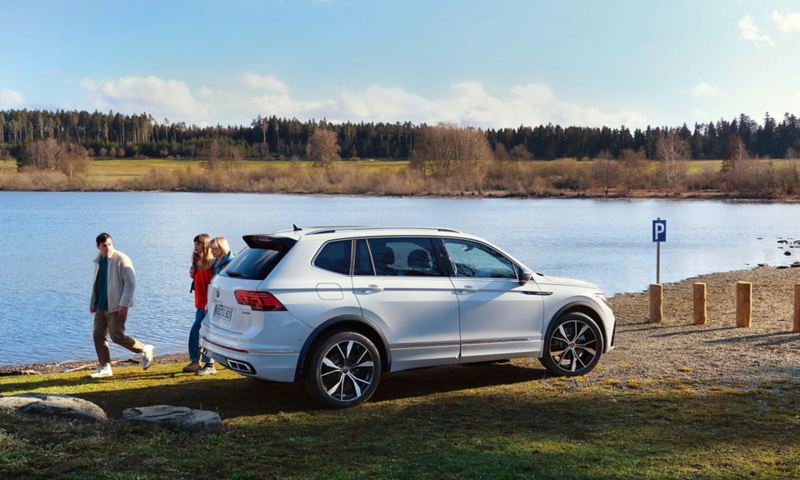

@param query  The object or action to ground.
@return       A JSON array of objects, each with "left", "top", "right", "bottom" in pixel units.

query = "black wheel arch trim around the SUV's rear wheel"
[{"left": 294, "top": 315, "right": 392, "bottom": 382}]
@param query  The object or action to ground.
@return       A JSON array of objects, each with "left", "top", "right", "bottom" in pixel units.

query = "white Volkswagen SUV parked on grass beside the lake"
[{"left": 200, "top": 227, "right": 615, "bottom": 408}]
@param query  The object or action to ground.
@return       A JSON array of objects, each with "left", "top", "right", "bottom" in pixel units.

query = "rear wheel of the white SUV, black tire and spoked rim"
[{"left": 303, "top": 332, "right": 383, "bottom": 408}]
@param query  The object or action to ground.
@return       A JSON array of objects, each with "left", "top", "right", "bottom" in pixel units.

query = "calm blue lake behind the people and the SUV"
[{"left": 0, "top": 192, "right": 800, "bottom": 365}]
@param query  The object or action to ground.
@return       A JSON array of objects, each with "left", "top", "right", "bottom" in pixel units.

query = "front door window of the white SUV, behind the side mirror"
[{"left": 444, "top": 238, "right": 517, "bottom": 280}]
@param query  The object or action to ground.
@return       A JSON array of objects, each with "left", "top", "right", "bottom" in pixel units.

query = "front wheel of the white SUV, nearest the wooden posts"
[{"left": 539, "top": 312, "right": 604, "bottom": 377}]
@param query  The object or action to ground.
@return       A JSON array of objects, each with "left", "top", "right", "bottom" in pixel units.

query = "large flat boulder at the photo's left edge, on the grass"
[{"left": 0, "top": 393, "right": 108, "bottom": 422}]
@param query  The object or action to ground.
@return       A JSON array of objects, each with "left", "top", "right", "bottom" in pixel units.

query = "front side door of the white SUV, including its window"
[{"left": 442, "top": 238, "right": 547, "bottom": 362}]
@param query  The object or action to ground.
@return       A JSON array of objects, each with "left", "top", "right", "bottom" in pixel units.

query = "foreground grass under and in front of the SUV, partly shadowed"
[{"left": 0, "top": 362, "right": 800, "bottom": 479}]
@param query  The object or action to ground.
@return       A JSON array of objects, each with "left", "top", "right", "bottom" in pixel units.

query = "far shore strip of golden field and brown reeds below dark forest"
[{"left": 0, "top": 159, "right": 800, "bottom": 203}]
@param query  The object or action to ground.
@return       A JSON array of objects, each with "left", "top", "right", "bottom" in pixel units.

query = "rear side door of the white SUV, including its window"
[{"left": 353, "top": 237, "right": 460, "bottom": 371}]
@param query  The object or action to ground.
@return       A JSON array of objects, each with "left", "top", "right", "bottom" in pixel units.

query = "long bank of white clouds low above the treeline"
[{"left": 81, "top": 72, "right": 646, "bottom": 128}]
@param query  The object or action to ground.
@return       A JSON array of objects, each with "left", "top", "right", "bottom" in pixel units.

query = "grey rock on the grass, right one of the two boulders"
[{"left": 121, "top": 405, "right": 225, "bottom": 433}]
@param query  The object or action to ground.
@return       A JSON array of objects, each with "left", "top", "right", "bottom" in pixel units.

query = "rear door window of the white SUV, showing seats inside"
[{"left": 369, "top": 237, "right": 446, "bottom": 277}]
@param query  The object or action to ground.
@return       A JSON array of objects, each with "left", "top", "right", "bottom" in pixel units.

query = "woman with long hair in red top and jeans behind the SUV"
[{"left": 183, "top": 233, "right": 217, "bottom": 375}]
